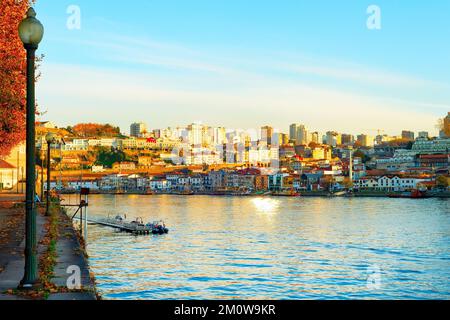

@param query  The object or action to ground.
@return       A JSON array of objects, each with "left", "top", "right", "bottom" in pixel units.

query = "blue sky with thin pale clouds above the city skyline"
[{"left": 36, "top": 0, "right": 450, "bottom": 134}]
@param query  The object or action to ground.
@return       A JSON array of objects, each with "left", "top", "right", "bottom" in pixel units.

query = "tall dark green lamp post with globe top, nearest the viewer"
[{"left": 19, "top": 8, "right": 44, "bottom": 289}]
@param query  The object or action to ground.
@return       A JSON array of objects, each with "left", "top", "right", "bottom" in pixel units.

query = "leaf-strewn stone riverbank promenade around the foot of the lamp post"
[{"left": 0, "top": 195, "right": 98, "bottom": 300}]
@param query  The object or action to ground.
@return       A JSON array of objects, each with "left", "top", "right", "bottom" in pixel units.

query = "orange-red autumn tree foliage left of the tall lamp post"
[{"left": 0, "top": 0, "right": 30, "bottom": 156}]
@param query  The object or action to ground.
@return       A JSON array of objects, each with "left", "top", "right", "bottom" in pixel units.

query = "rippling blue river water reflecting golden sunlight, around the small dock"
[{"left": 71, "top": 195, "right": 450, "bottom": 300}]
